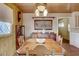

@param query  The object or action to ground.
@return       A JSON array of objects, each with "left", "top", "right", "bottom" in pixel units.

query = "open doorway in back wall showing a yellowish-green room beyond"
[{"left": 58, "top": 18, "right": 69, "bottom": 44}]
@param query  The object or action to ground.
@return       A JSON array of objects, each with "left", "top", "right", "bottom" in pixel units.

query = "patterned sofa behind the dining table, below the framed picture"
[{"left": 31, "top": 32, "right": 56, "bottom": 41}]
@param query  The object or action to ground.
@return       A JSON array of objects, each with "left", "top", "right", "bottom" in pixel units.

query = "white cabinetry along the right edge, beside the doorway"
[{"left": 70, "top": 11, "right": 79, "bottom": 48}]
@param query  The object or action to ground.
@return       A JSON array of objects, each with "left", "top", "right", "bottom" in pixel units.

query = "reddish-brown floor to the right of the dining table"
[{"left": 63, "top": 43, "right": 79, "bottom": 56}]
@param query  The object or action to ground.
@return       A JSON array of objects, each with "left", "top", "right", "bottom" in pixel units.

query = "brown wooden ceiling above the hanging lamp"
[{"left": 15, "top": 3, "right": 79, "bottom": 13}]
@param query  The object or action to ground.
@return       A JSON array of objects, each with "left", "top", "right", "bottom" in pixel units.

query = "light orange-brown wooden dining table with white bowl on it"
[{"left": 17, "top": 38, "right": 65, "bottom": 54}]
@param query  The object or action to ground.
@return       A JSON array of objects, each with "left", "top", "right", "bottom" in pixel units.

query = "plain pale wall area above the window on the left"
[{"left": 0, "top": 4, "right": 13, "bottom": 23}]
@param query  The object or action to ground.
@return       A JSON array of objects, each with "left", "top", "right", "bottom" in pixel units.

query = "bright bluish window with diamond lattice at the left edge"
[{"left": 0, "top": 22, "right": 11, "bottom": 35}]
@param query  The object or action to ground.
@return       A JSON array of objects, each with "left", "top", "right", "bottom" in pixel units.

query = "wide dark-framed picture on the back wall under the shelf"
[{"left": 34, "top": 20, "right": 52, "bottom": 30}]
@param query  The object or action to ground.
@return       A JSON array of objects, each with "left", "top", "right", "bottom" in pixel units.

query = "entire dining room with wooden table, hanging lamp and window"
[{"left": 0, "top": 3, "right": 79, "bottom": 56}]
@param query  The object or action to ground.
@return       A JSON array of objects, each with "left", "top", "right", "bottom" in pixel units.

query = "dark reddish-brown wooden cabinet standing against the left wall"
[{"left": 16, "top": 25, "right": 25, "bottom": 49}]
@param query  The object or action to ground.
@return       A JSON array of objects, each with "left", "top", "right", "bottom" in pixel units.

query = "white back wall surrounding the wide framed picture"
[{"left": 23, "top": 13, "right": 70, "bottom": 37}]
